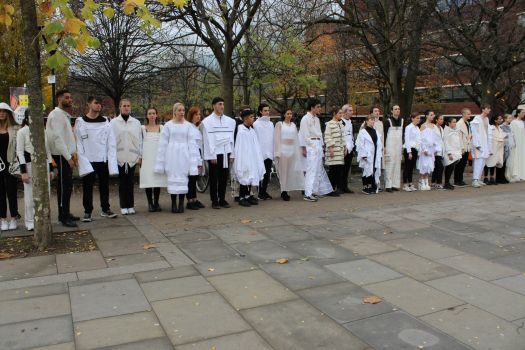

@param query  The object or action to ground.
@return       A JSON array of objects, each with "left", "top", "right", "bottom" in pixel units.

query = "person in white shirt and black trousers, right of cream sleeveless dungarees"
[{"left": 403, "top": 114, "right": 421, "bottom": 192}]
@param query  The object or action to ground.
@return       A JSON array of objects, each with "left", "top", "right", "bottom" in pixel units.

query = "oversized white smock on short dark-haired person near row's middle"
[{"left": 233, "top": 124, "right": 266, "bottom": 186}]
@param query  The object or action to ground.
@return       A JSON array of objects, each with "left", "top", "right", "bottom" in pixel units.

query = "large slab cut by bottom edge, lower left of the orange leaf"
[{"left": 241, "top": 300, "right": 368, "bottom": 350}]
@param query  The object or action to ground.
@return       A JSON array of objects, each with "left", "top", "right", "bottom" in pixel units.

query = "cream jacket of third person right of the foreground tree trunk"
[{"left": 111, "top": 115, "right": 142, "bottom": 166}]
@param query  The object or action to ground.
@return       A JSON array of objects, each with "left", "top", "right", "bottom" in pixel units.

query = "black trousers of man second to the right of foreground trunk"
[{"left": 82, "top": 162, "right": 109, "bottom": 214}]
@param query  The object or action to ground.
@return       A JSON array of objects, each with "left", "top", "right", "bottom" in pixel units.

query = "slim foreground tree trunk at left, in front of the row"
[{"left": 20, "top": 0, "right": 53, "bottom": 250}]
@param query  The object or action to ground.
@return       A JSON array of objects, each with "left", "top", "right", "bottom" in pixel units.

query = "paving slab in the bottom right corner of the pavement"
[{"left": 421, "top": 304, "right": 525, "bottom": 350}]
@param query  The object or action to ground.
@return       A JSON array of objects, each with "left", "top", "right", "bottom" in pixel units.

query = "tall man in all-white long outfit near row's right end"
[{"left": 470, "top": 104, "right": 492, "bottom": 188}]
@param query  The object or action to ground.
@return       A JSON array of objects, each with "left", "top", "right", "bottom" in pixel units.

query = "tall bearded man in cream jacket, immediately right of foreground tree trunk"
[{"left": 46, "top": 90, "right": 80, "bottom": 227}]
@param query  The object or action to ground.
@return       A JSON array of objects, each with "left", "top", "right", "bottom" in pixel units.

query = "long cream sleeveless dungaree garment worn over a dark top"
[{"left": 385, "top": 119, "right": 404, "bottom": 188}]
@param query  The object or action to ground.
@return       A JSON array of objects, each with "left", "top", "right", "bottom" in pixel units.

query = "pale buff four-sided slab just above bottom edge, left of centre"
[{"left": 152, "top": 293, "right": 250, "bottom": 345}]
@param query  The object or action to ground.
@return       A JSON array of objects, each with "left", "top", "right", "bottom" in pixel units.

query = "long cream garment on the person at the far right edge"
[{"left": 505, "top": 119, "right": 525, "bottom": 182}]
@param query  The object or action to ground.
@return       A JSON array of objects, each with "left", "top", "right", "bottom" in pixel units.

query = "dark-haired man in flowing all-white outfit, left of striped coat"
[{"left": 299, "top": 98, "right": 333, "bottom": 202}]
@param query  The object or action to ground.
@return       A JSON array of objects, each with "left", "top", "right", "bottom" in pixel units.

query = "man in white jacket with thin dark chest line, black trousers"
[{"left": 202, "top": 97, "right": 236, "bottom": 209}]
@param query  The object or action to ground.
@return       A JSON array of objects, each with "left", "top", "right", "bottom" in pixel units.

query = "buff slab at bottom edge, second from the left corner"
[{"left": 75, "top": 312, "right": 165, "bottom": 350}]
